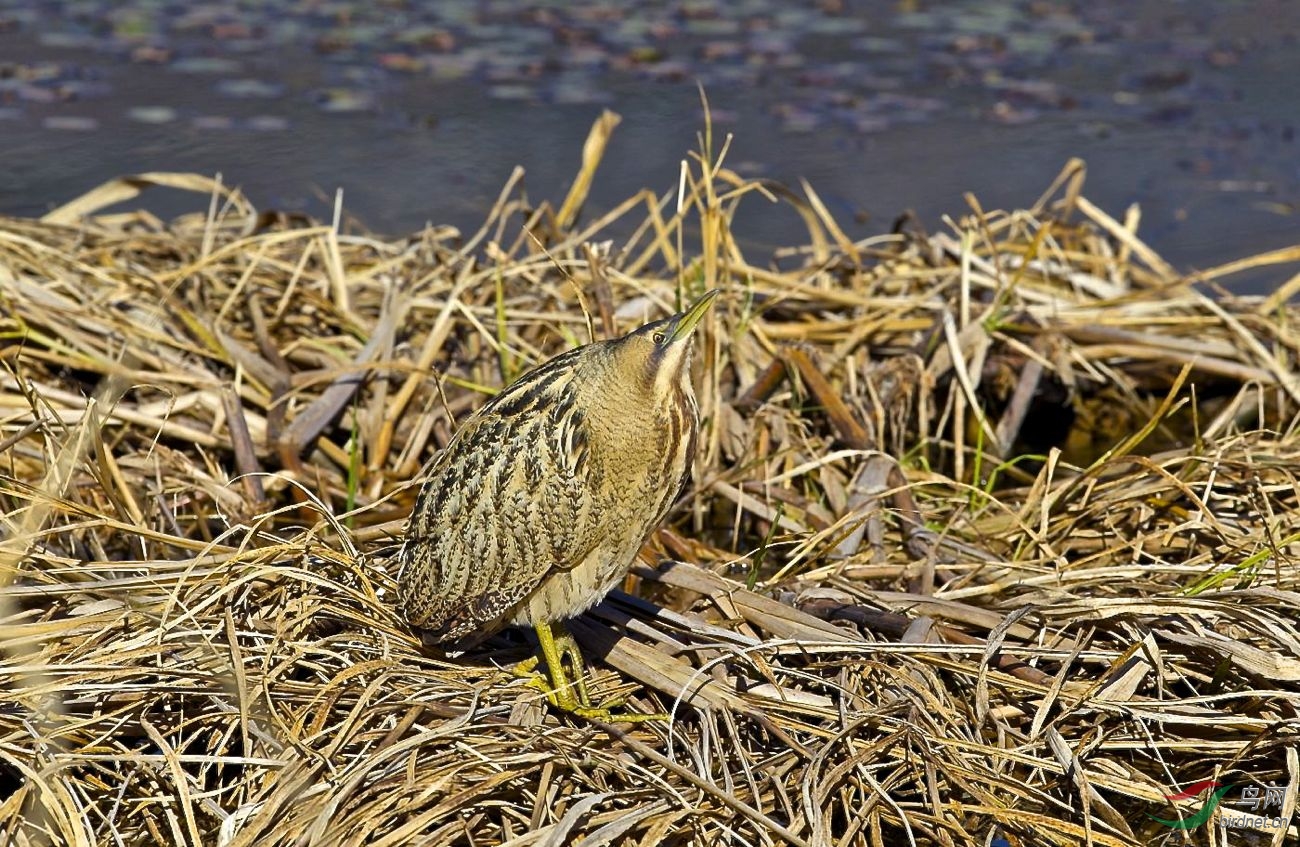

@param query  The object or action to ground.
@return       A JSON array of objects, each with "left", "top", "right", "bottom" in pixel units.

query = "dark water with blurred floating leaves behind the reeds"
[{"left": 0, "top": 0, "right": 1300, "bottom": 287}]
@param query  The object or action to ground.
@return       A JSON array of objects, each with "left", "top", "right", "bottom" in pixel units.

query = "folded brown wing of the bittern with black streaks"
[{"left": 400, "top": 366, "right": 598, "bottom": 640}]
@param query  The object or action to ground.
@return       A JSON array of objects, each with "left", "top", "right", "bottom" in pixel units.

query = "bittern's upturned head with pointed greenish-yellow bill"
[{"left": 610, "top": 288, "right": 718, "bottom": 401}]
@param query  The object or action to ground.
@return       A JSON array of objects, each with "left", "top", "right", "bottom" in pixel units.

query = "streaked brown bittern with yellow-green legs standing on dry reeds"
[{"left": 398, "top": 290, "right": 718, "bottom": 720}]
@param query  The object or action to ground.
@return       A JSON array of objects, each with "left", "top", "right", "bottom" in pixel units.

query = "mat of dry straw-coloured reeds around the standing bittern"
[{"left": 0, "top": 115, "right": 1300, "bottom": 847}]
